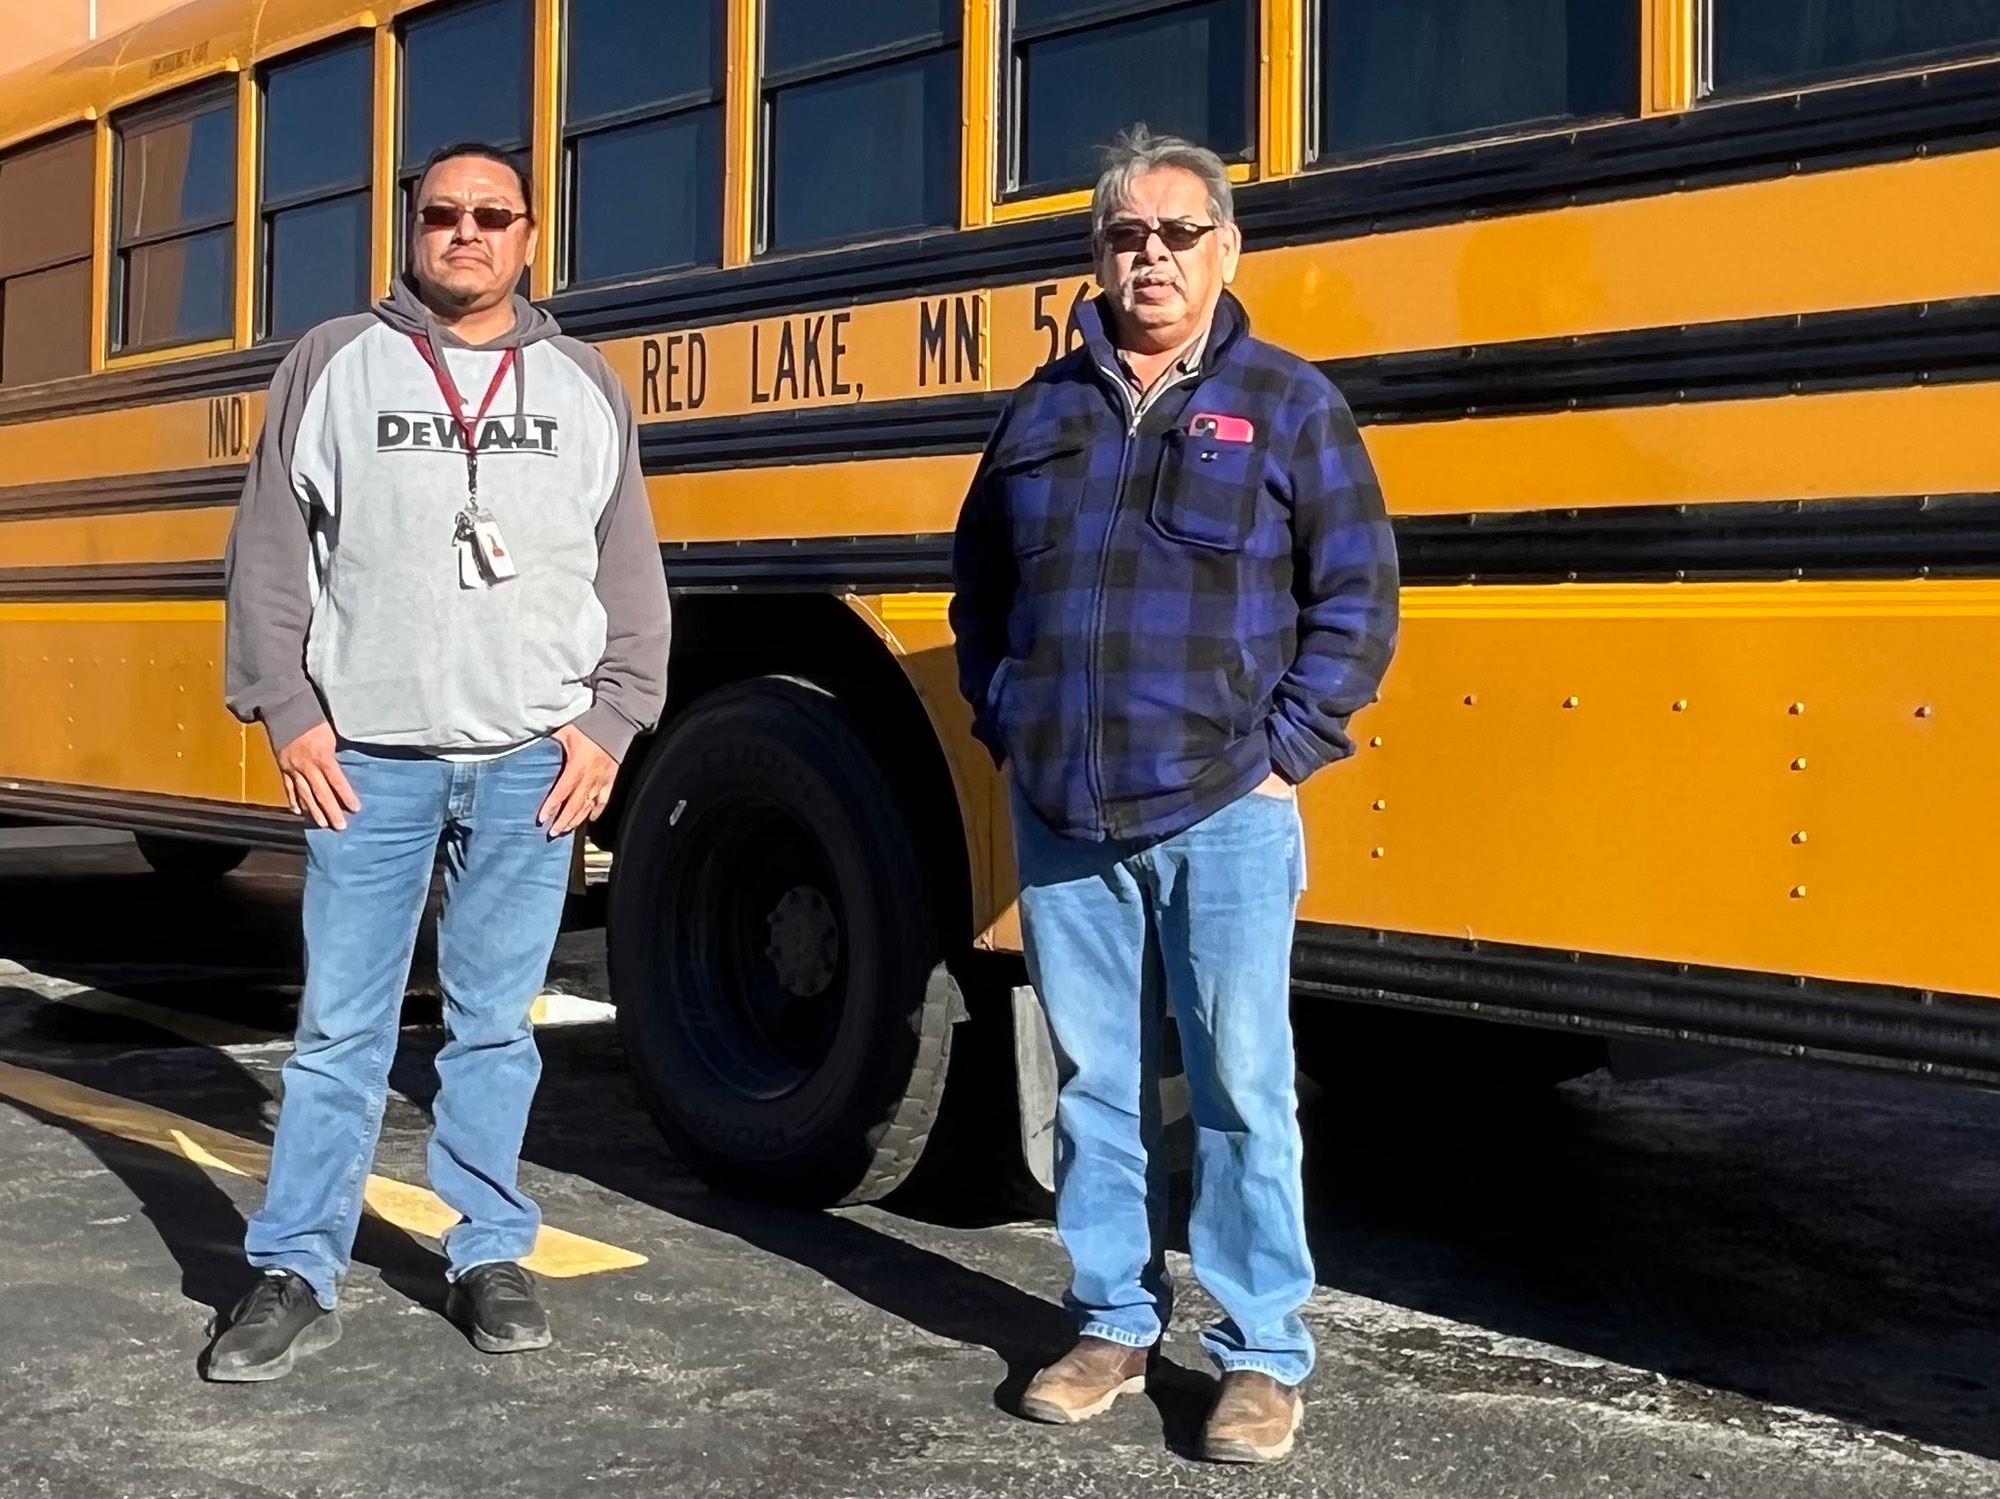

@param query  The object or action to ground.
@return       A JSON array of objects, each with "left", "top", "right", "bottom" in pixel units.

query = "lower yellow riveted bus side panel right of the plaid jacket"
[{"left": 1302, "top": 580, "right": 2000, "bottom": 995}]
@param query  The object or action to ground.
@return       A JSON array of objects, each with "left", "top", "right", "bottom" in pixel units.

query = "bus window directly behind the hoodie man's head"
[{"left": 396, "top": 0, "right": 544, "bottom": 252}]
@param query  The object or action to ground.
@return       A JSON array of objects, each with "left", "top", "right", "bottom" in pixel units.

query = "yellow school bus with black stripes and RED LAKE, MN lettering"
[{"left": 0, "top": 0, "right": 2000, "bottom": 1199}]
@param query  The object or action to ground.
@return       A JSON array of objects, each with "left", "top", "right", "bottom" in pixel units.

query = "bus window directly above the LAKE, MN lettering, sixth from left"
[{"left": 762, "top": 0, "right": 960, "bottom": 250}]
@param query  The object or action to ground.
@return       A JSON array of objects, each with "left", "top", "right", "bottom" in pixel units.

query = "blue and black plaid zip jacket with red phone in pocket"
[{"left": 952, "top": 294, "right": 1396, "bottom": 839}]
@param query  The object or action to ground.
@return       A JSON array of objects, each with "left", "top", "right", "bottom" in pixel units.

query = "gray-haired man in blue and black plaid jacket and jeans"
[{"left": 952, "top": 126, "right": 1396, "bottom": 1461}]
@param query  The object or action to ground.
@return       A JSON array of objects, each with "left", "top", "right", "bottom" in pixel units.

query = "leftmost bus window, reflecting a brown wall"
[{"left": 0, "top": 130, "right": 94, "bottom": 386}]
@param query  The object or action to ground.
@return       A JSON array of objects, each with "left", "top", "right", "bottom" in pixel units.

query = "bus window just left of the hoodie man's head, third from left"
[{"left": 258, "top": 36, "right": 374, "bottom": 338}]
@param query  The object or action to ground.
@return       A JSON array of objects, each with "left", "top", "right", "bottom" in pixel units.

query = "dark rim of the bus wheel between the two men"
[{"left": 658, "top": 797, "right": 850, "bottom": 1099}]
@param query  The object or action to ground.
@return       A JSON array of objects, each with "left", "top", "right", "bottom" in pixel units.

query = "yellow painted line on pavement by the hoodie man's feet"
[{"left": 0, "top": 1061, "right": 646, "bottom": 1279}]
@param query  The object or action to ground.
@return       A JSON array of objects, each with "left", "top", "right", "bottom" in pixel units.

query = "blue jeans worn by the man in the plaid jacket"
[{"left": 1014, "top": 791, "right": 1314, "bottom": 1385}]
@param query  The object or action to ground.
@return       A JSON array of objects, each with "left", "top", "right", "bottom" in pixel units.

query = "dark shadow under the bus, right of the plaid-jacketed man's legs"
[{"left": 1306, "top": 1063, "right": 2000, "bottom": 1457}]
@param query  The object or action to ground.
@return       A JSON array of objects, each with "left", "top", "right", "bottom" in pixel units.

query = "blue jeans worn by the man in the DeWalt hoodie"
[{"left": 244, "top": 740, "right": 570, "bottom": 1307}]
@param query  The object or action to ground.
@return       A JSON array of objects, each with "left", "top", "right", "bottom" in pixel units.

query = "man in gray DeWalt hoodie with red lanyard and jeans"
[{"left": 208, "top": 144, "right": 668, "bottom": 1381}]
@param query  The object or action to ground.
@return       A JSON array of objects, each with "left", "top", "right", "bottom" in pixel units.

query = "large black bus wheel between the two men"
[{"left": 608, "top": 678, "right": 962, "bottom": 1205}]
